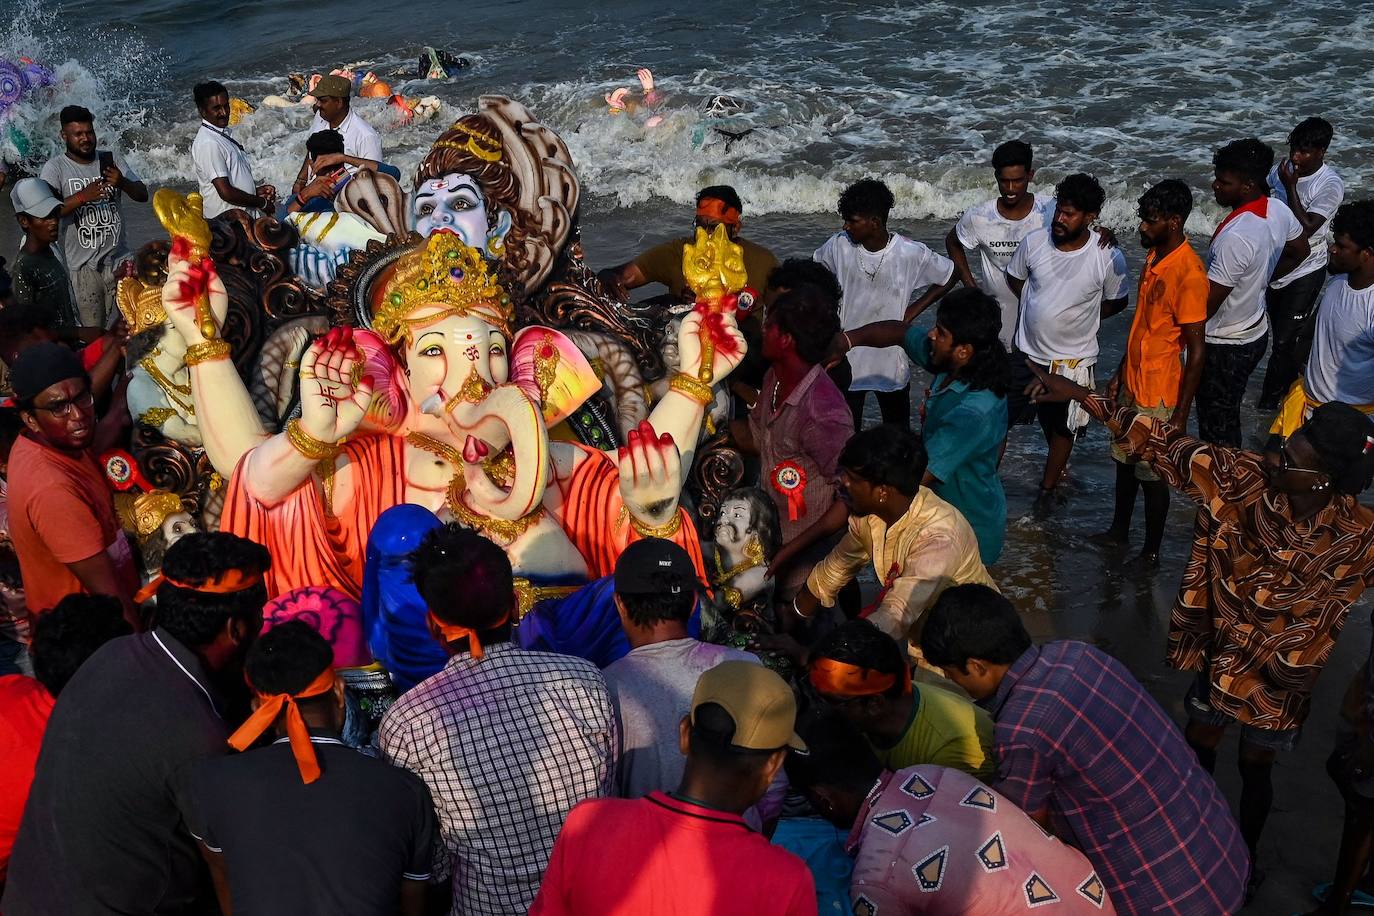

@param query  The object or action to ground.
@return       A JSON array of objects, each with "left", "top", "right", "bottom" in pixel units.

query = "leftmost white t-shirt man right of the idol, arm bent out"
[{"left": 812, "top": 179, "right": 959, "bottom": 430}]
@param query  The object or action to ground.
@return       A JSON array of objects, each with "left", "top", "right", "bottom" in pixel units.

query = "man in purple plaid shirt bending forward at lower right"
[{"left": 921, "top": 585, "right": 1250, "bottom": 915}]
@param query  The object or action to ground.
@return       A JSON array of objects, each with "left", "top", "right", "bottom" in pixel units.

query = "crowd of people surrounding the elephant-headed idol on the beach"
[{"left": 0, "top": 76, "right": 1374, "bottom": 916}]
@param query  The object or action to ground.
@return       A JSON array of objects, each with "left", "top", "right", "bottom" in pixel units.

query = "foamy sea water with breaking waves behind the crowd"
[{"left": 10, "top": 0, "right": 1374, "bottom": 240}]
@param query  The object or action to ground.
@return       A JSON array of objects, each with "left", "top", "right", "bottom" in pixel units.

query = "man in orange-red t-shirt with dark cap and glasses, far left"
[{"left": 8, "top": 343, "right": 139, "bottom": 626}]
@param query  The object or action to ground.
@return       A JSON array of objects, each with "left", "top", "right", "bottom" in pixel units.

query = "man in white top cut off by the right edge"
[{"left": 1303, "top": 201, "right": 1374, "bottom": 412}]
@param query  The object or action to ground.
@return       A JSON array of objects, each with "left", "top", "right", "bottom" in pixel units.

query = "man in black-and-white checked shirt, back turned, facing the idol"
[{"left": 379, "top": 525, "right": 620, "bottom": 916}]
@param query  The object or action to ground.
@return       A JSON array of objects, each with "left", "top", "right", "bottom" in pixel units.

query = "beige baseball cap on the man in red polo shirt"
[{"left": 691, "top": 662, "right": 807, "bottom": 751}]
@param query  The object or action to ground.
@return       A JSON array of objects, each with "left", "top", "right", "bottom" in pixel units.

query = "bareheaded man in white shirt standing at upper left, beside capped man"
[{"left": 191, "top": 80, "right": 276, "bottom": 220}]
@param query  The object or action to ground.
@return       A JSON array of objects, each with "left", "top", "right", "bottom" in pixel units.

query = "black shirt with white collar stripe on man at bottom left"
[{"left": 0, "top": 629, "right": 230, "bottom": 916}]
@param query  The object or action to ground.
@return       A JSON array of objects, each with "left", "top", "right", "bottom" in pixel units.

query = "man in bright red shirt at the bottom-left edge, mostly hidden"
[{"left": 0, "top": 595, "right": 132, "bottom": 887}]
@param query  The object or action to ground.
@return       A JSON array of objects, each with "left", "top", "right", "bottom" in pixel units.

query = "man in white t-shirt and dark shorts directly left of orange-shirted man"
[{"left": 1007, "top": 173, "right": 1129, "bottom": 501}]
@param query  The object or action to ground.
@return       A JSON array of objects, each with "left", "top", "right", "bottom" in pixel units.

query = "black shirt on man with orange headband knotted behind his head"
[{"left": 190, "top": 736, "right": 438, "bottom": 916}]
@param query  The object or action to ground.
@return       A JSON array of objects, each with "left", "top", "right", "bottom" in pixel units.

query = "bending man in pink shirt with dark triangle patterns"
[{"left": 787, "top": 713, "right": 1116, "bottom": 916}]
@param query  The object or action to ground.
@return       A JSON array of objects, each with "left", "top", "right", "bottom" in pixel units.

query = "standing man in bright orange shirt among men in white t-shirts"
[{"left": 1102, "top": 179, "right": 1208, "bottom": 567}]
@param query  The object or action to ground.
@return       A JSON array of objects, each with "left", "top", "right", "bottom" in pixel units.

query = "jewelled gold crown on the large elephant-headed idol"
[{"left": 372, "top": 232, "right": 515, "bottom": 343}]
